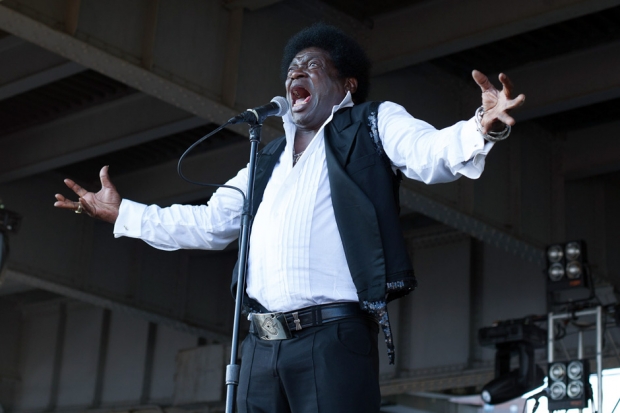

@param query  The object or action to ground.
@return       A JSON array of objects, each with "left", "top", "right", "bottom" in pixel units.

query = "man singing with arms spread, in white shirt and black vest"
[{"left": 54, "top": 25, "right": 525, "bottom": 413}]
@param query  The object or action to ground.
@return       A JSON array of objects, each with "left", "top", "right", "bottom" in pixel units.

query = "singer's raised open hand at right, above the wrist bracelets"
[{"left": 471, "top": 70, "right": 525, "bottom": 134}]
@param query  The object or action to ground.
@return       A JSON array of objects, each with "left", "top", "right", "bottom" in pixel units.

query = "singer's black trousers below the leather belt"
[{"left": 237, "top": 317, "right": 381, "bottom": 413}]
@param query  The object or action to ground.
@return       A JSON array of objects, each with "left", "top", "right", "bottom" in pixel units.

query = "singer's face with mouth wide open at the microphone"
[{"left": 285, "top": 47, "right": 349, "bottom": 131}]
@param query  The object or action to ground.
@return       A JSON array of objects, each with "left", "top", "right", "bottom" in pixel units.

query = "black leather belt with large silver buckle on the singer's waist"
[{"left": 250, "top": 303, "right": 370, "bottom": 340}]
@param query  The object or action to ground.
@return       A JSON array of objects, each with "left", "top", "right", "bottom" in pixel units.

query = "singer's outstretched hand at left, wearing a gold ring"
[{"left": 54, "top": 166, "right": 121, "bottom": 224}]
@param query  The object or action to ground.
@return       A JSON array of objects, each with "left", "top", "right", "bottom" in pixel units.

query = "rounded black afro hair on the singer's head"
[{"left": 281, "top": 23, "right": 370, "bottom": 103}]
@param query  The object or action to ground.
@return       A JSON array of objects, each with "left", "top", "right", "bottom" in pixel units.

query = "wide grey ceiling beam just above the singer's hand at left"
[{"left": 0, "top": 93, "right": 208, "bottom": 183}]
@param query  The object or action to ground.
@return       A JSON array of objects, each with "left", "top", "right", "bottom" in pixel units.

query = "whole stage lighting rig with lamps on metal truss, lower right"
[{"left": 478, "top": 241, "right": 620, "bottom": 412}]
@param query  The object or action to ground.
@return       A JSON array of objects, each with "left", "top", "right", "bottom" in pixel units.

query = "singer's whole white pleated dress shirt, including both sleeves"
[{"left": 114, "top": 94, "right": 493, "bottom": 311}]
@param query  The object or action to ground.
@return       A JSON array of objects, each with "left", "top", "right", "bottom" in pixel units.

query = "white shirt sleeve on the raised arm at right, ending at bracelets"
[{"left": 377, "top": 102, "right": 493, "bottom": 184}]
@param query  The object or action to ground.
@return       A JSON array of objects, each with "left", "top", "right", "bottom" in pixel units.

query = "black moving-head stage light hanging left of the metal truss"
[{"left": 478, "top": 316, "right": 547, "bottom": 404}]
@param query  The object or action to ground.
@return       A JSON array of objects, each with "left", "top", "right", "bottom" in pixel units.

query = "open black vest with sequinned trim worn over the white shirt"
[{"left": 232, "top": 102, "right": 416, "bottom": 362}]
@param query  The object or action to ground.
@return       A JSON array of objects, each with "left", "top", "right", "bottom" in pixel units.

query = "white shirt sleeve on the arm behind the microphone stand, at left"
[{"left": 114, "top": 168, "right": 248, "bottom": 251}]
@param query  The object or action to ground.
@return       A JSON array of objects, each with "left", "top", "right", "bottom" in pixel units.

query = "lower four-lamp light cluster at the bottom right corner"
[{"left": 547, "top": 360, "right": 592, "bottom": 411}]
